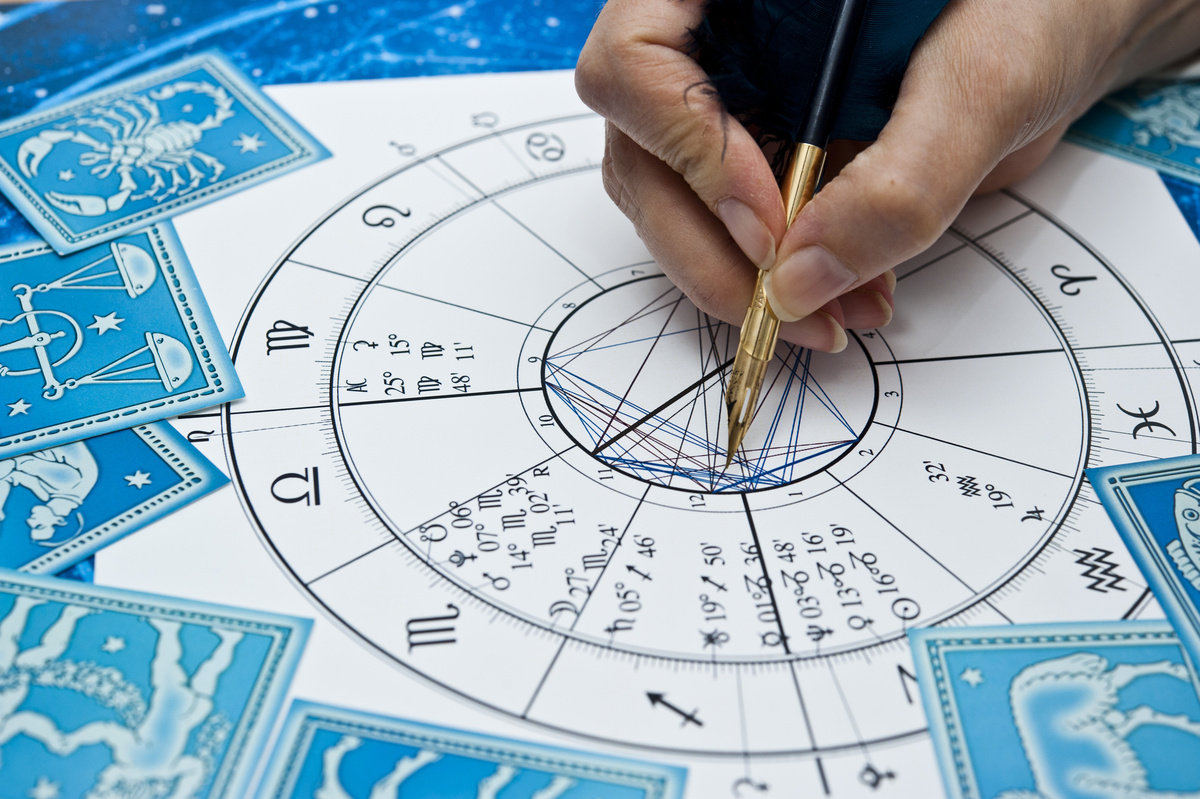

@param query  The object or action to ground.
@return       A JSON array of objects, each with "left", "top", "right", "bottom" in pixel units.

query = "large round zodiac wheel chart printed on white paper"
[{"left": 224, "top": 91, "right": 1200, "bottom": 797}]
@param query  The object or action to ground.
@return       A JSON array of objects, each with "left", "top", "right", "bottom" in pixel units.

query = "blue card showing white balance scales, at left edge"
[{"left": 0, "top": 222, "right": 242, "bottom": 458}]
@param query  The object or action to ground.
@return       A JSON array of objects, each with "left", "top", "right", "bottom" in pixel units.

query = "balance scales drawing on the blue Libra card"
[{"left": 0, "top": 242, "right": 194, "bottom": 400}]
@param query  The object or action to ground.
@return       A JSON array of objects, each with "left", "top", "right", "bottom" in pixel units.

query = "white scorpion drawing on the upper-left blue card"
[{"left": 17, "top": 80, "right": 234, "bottom": 216}]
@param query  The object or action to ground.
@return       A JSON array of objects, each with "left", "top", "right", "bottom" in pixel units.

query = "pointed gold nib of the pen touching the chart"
[{"left": 725, "top": 272, "right": 779, "bottom": 469}]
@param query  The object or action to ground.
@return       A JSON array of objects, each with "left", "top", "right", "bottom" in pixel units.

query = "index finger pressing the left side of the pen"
[{"left": 575, "top": 0, "right": 785, "bottom": 269}]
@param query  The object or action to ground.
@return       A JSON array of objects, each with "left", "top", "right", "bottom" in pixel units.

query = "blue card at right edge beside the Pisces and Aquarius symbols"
[{"left": 1087, "top": 455, "right": 1200, "bottom": 663}]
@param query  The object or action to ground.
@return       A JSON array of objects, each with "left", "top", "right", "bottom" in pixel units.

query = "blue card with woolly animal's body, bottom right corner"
[{"left": 908, "top": 621, "right": 1200, "bottom": 799}]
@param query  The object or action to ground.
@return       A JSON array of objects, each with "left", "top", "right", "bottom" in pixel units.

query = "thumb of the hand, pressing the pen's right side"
[{"left": 767, "top": 38, "right": 1028, "bottom": 320}]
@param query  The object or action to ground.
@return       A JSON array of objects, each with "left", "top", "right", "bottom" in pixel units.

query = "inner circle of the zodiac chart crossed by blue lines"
[{"left": 542, "top": 275, "right": 877, "bottom": 493}]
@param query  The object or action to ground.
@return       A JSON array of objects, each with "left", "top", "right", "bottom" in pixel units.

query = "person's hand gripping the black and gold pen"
[{"left": 576, "top": 0, "right": 1200, "bottom": 352}]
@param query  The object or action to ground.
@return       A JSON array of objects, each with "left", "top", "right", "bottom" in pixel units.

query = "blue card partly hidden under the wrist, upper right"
[{"left": 1067, "top": 80, "right": 1200, "bottom": 182}]
